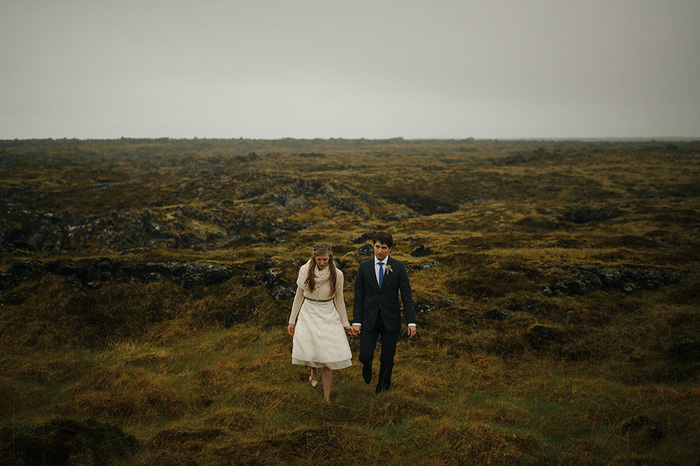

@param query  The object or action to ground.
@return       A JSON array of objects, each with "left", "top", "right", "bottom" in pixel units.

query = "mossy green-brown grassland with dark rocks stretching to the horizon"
[{"left": 0, "top": 139, "right": 700, "bottom": 465}]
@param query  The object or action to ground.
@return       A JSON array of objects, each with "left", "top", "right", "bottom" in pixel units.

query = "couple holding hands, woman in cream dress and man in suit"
[{"left": 287, "top": 231, "right": 416, "bottom": 401}]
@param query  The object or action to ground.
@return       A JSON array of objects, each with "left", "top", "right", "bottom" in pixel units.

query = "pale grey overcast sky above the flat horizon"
[{"left": 0, "top": 0, "right": 700, "bottom": 139}]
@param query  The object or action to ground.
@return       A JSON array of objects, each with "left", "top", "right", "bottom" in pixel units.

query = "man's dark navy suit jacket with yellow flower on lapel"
[{"left": 352, "top": 256, "right": 416, "bottom": 332}]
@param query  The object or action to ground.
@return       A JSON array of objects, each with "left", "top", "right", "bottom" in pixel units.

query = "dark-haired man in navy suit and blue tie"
[{"left": 352, "top": 231, "right": 416, "bottom": 393}]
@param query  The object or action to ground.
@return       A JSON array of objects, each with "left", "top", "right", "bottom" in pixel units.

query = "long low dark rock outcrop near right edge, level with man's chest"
[{"left": 542, "top": 266, "right": 683, "bottom": 297}]
